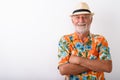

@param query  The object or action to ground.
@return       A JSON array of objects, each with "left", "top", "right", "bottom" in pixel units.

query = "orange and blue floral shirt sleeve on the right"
[{"left": 98, "top": 37, "right": 111, "bottom": 60}]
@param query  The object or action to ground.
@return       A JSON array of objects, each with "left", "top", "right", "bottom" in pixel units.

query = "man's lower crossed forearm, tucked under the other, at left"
[{"left": 59, "top": 63, "right": 89, "bottom": 75}]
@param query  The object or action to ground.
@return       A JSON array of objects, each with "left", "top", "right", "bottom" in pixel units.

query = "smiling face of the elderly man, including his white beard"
[{"left": 71, "top": 14, "right": 92, "bottom": 34}]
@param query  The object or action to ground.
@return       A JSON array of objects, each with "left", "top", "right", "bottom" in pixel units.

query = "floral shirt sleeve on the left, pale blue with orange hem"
[{"left": 58, "top": 37, "right": 70, "bottom": 67}]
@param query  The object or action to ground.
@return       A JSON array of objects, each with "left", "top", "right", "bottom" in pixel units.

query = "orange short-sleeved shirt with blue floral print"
[{"left": 58, "top": 33, "right": 111, "bottom": 80}]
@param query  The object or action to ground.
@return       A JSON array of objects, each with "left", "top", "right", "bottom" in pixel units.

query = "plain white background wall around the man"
[{"left": 0, "top": 0, "right": 120, "bottom": 80}]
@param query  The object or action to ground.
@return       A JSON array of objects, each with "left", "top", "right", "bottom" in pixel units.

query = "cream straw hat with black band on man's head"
[{"left": 71, "top": 2, "right": 94, "bottom": 16}]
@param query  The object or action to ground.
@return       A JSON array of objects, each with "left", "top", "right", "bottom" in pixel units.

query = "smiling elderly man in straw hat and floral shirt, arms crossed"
[{"left": 58, "top": 2, "right": 112, "bottom": 80}]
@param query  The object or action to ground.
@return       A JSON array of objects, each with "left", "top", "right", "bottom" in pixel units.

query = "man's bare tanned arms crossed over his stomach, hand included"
[{"left": 59, "top": 55, "right": 112, "bottom": 75}]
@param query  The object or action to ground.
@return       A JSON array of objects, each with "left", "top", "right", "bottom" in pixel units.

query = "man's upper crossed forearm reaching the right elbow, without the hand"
[{"left": 79, "top": 57, "right": 112, "bottom": 72}]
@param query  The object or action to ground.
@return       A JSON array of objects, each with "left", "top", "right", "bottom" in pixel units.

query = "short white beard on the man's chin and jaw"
[{"left": 75, "top": 24, "right": 90, "bottom": 34}]
